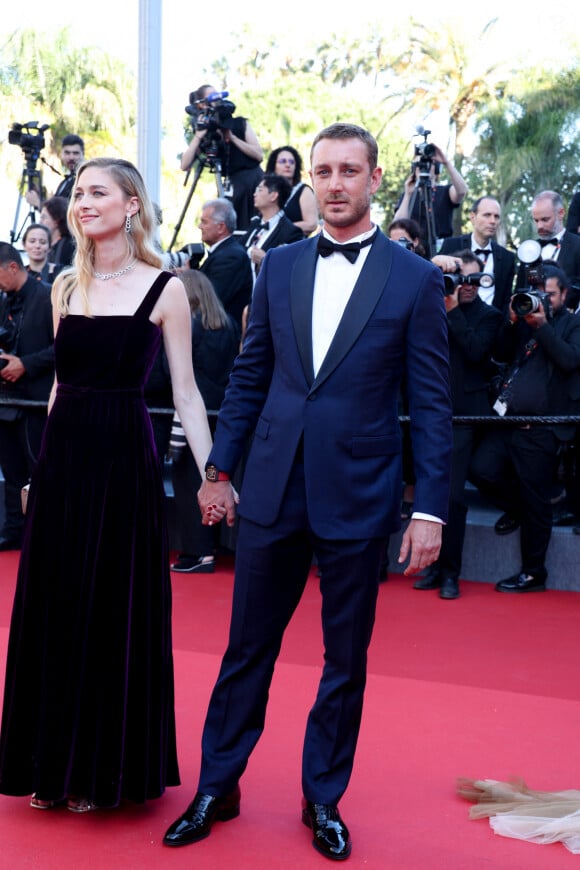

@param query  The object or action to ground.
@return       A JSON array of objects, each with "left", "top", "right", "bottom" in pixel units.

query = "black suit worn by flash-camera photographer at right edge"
[{"left": 470, "top": 307, "right": 580, "bottom": 591}]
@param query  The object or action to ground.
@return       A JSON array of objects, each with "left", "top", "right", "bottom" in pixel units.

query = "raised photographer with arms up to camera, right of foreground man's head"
[{"left": 393, "top": 126, "right": 467, "bottom": 257}]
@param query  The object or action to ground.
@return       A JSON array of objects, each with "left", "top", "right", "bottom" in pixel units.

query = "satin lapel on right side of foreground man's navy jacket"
[{"left": 311, "top": 231, "right": 393, "bottom": 388}]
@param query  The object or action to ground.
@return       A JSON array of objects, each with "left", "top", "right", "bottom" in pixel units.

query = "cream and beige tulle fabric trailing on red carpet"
[{"left": 457, "top": 779, "right": 580, "bottom": 855}]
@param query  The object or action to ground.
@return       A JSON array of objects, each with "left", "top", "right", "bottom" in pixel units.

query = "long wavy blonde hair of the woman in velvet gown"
[{"left": 52, "top": 157, "right": 161, "bottom": 317}]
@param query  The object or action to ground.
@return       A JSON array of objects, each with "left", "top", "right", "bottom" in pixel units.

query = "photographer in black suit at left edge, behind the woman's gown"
[{"left": 0, "top": 242, "right": 54, "bottom": 550}]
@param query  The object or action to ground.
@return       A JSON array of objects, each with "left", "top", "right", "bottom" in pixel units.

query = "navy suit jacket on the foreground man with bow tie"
[{"left": 209, "top": 231, "right": 452, "bottom": 540}]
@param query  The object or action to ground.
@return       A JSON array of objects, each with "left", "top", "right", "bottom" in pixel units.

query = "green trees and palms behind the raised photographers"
[{"left": 0, "top": 16, "right": 580, "bottom": 252}]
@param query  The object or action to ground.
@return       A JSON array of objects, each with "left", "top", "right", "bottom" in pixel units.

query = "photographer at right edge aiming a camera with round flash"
[{"left": 470, "top": 262, "right": 580, "bottom": 593}]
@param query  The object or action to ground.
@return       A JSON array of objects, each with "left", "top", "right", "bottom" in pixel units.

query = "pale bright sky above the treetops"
[{"left": 5, "top": 0, "right": 578, "bottom": 112}]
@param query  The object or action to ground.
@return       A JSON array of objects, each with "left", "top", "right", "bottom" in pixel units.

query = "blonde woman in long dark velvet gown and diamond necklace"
[{"left": 0, "top": 158, "right": 217, "bottom": 812}]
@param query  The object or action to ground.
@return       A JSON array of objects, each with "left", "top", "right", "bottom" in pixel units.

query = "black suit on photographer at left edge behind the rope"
[{"left": 0, "top": 276, "right": 54, "bottom": 544}]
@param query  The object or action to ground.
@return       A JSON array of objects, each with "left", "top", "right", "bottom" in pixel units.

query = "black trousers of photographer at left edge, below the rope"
[{"left": 0, "top": 410, "right": 46, "bottom": 541}]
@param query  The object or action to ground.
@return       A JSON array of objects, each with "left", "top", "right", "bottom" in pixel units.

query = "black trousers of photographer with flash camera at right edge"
[{"left": 470, "top": 426, "right": 560, "bottom": 575}]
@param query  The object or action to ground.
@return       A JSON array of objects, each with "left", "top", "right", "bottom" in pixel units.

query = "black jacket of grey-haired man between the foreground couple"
[{"left": 200, "top": 236, "right": 253, "bottom": 330}]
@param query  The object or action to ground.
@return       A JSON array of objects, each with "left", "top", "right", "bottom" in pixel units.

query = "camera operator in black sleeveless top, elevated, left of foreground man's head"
[{"left": 181, "top": 85, "right": 264, "bottom": 230}]
